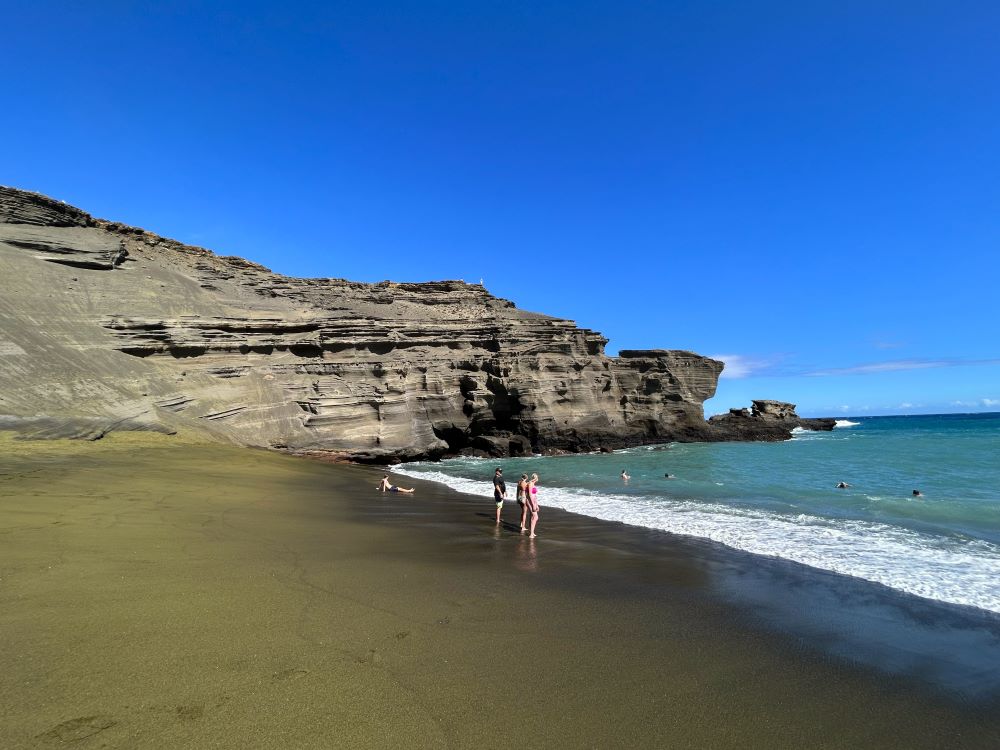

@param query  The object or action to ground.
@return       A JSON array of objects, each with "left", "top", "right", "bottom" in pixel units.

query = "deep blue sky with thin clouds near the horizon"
[{"left": 0, "top": 0, "right": 1000, "bottom": 415}]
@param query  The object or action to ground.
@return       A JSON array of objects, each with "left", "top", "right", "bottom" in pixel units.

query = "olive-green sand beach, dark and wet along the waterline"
[{"left": 0, "top": 433, "right": 1000, "bottom": 748}]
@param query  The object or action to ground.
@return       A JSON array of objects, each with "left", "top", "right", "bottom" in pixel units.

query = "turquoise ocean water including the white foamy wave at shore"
[{"left": 394, "top": 413, "right": 1000, "bottom": 612}]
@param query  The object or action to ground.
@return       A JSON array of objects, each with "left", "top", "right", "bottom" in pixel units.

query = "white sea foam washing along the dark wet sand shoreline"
[{"left": 393, "top": 468, "right": 1000, "bottom": 612}]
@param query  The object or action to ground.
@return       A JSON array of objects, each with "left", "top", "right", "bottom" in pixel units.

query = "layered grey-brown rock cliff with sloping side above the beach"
[{"left": 0, "top": 188, "right": 744, "bottom": 461}]
